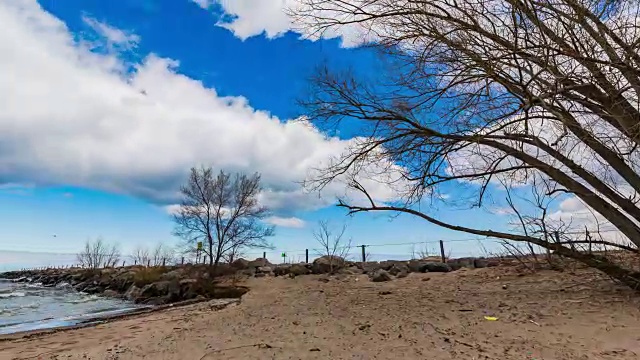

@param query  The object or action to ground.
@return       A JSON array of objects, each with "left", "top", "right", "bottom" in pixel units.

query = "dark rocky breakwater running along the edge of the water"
[{"left": 0, "top": 265, "right": 248, "bottom": 305}]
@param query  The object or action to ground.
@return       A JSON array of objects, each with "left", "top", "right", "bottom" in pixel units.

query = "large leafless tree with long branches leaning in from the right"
[{"left": 290, "top": 0, "right": 640, "bottom": 288}]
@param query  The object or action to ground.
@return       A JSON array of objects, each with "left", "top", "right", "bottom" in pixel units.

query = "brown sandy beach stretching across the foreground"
[{"left": 0, "top": 268, "right": 640, "bottom": 360}]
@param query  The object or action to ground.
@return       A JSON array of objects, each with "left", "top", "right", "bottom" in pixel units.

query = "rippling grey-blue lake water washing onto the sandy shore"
[{"left": 0, "top": 279, "right": 142, "bottom": 335}]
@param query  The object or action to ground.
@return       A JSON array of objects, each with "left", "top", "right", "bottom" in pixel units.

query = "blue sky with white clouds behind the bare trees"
[{"left": 0, "top": 0, "right": 604, "bottom": 264}]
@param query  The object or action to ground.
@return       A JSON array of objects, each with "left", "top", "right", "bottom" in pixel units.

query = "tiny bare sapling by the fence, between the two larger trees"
[{"left": 313, "top": 220, "right": 351, "bottom": 273}]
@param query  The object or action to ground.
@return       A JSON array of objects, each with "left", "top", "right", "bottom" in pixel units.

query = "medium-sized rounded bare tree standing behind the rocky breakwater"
[{"left": 174, "top": 167, "right": 274, "bottom": 273}]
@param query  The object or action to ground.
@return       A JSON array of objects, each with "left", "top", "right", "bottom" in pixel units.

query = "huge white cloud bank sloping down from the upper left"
[{"left": 0, "top": 0, "right": 395, "bottom": 210}]
